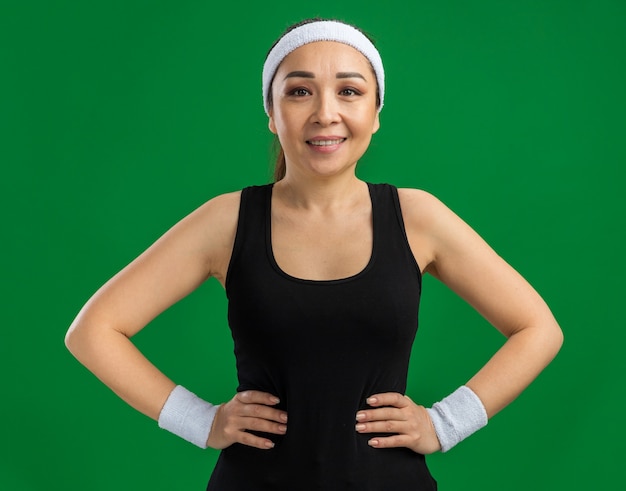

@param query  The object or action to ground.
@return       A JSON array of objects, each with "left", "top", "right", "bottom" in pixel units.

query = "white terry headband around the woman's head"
[{"left": 263, "top": 20, "right": 385, "bottom": 116}]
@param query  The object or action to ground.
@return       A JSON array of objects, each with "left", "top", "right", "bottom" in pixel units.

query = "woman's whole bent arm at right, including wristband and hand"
[{"left": 356, "top": 189, "right": 563, "bottom": 453}]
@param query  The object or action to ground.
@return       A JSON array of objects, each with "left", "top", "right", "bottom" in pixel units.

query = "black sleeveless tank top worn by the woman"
[{"left": 207, "top": 184, "right": 437, "bottom": 491}]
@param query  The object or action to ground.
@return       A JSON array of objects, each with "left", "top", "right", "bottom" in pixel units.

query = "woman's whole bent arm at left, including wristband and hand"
[{"left": 65, "top": 193, "right": 287, "bottom": 449}]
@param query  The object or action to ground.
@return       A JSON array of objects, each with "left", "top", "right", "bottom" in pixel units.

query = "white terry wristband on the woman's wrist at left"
[{"left": 158, "top": 385, "right": 219, "bottom": 448}]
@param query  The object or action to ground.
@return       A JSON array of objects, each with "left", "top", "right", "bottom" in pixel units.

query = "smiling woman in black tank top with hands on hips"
[{"left": 66, "top": 20, "right": 562, "bottom": 491}]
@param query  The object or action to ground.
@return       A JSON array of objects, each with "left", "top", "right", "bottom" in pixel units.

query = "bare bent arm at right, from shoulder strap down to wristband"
[{"left": 400, "top": 189, "right": 563, "bottom": 417}]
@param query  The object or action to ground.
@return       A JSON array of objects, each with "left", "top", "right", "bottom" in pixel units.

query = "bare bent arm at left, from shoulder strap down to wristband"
[{"left": 65, "top": 193, "right": 239, "bottom": 419}]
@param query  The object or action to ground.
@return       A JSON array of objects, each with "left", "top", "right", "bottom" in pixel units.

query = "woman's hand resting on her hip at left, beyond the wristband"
[{"left": 207, "top": 390, "right": 287, "bottom": 449}]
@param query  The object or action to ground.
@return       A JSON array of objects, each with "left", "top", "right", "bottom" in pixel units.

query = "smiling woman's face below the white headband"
[{"left": 269, "top": 41, "right": 379, "bottom": 177}]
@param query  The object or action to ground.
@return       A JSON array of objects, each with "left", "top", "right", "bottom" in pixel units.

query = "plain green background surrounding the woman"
[{"left": 0, "top": 0, "right": 626, "bottom": 491}]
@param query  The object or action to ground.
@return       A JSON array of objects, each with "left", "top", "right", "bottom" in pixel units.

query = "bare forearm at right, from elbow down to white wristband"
[{"left": 467, "top": 320, "right": 563, "bottom": 418}]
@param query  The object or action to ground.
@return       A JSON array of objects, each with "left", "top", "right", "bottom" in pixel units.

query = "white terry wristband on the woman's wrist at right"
[{"left": 426, "top": 385, "right": 488, "bottom": 452}]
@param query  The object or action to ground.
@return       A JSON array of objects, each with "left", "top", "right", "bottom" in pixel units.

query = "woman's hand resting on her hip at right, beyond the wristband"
[{"left": 356, "top": 392, "right": 441, "bottom": 454}]
